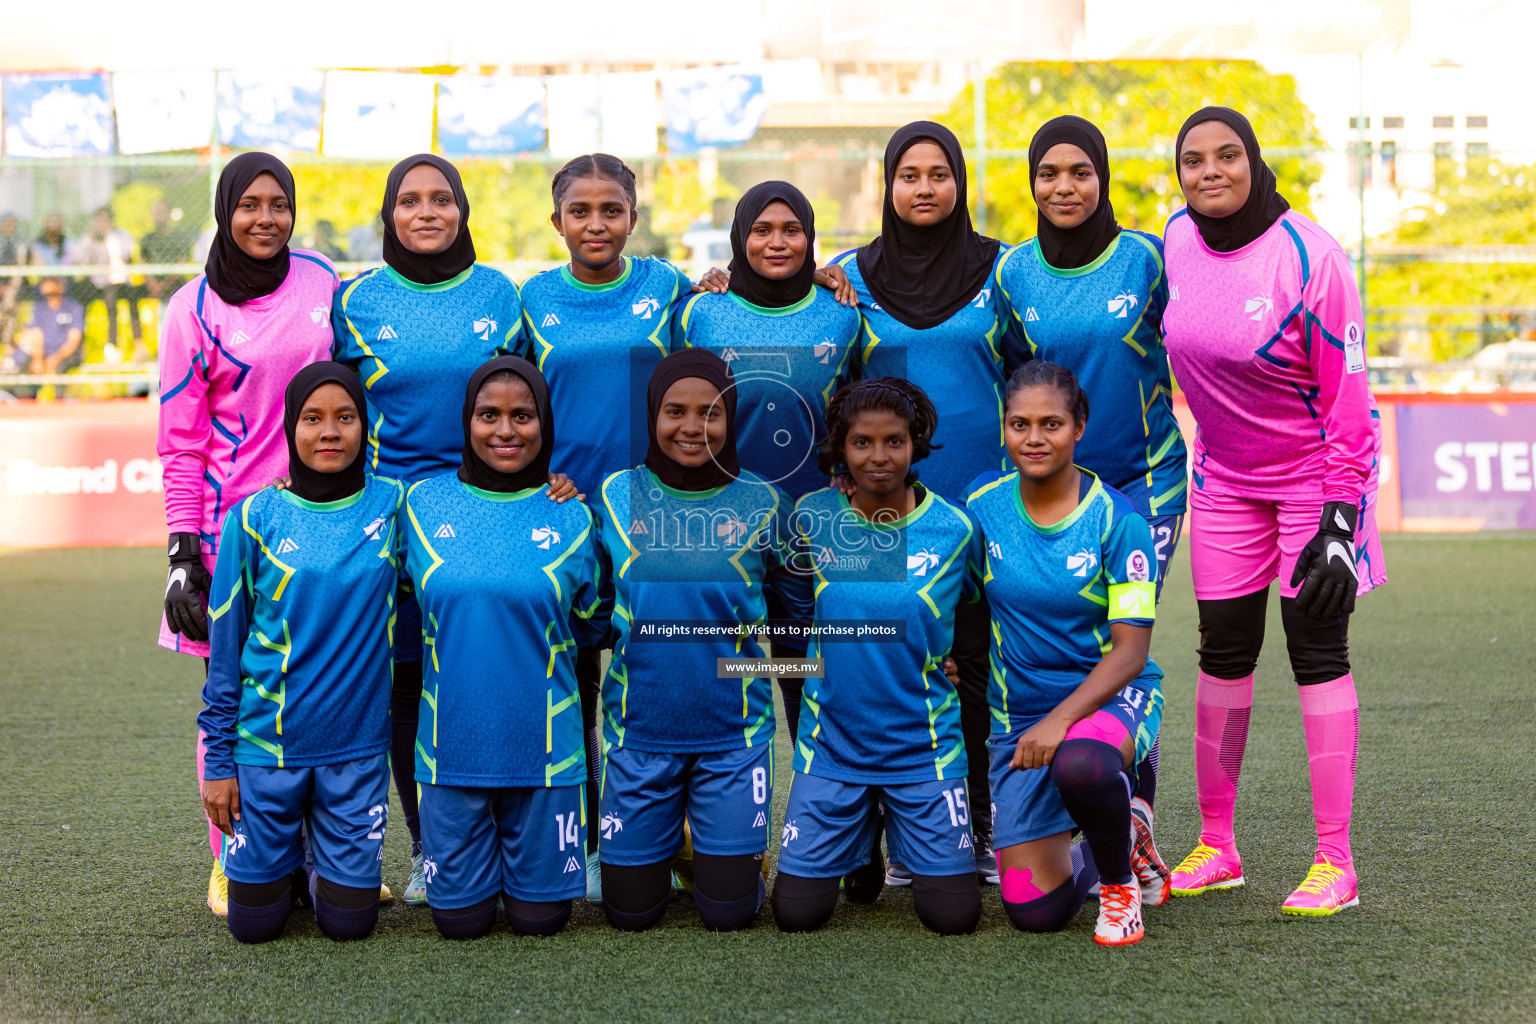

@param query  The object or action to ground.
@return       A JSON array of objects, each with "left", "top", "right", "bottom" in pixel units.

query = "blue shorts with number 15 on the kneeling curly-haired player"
[{"left": 779, "top": 772, "right": 975, "bottom": 878}]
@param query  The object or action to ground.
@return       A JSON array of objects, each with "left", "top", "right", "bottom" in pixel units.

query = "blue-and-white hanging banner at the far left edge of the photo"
[{"left": 5, "top": 75, "right": 112, "bottom": 157}]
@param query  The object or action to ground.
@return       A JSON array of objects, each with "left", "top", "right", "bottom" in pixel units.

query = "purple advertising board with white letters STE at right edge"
[{"left": 1396, "top": 401, "right": 1536, "bottom": 530}]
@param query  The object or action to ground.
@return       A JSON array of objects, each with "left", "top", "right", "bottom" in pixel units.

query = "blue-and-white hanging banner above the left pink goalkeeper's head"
[{"left": 218, "top": 71, "right": 326, "bottom": 154}]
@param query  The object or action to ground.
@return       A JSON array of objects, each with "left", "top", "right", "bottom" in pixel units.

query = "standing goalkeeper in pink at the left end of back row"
[{"left": 157, "top": 154, "right": 338, "bottom": 917}]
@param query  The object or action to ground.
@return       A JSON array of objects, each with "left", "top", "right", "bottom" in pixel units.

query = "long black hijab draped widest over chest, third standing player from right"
[{"left": 859, "top": 121, "right": 998, "bottom": 330}]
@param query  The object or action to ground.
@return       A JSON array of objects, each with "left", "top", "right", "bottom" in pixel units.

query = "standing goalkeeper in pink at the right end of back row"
[{"left": 1163, "top": 107, "right": 1387, "bottom": 915}]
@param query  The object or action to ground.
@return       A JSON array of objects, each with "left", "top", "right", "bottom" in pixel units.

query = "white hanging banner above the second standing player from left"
[{"left": 323, "top": 71, "right": 436, "bottom": 160}]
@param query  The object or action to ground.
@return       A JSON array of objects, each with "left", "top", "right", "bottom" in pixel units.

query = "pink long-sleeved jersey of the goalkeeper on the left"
[{"left": 157, "top": 249, "right": 338, "bottom": 656}]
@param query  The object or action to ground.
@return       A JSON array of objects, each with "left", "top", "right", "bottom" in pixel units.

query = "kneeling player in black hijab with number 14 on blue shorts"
[{"left": 406, "top": 356, "right": 610, "bottom": 938}]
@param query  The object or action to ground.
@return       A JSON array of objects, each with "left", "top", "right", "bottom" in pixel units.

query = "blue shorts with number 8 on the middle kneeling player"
[{"left": 598, "top": 742, "right": 774, "bottom": 867}]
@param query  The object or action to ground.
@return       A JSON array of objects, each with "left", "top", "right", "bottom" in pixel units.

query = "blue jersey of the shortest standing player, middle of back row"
[{"left": 673, "top": 287, "right": 862, "bottom": 497}]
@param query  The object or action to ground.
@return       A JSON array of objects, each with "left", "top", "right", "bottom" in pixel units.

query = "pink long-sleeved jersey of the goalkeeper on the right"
[{"left": 1163, "top": 210, "right": 1381, "bottom": 505}]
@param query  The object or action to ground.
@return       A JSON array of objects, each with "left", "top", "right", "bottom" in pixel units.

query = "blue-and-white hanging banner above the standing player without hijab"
[{"left": 438, "top": 75, "right": 545, "bottom": 157}]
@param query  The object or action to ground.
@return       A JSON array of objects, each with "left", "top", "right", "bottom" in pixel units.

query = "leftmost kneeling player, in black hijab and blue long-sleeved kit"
[{"left": 198, "top": 362, "right": 401, "bottom": 943}]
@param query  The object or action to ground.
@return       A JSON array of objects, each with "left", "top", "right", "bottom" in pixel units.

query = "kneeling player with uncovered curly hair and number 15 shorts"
[{"left": 773, "top": 378, "right": 982, "bottom": 935}]
